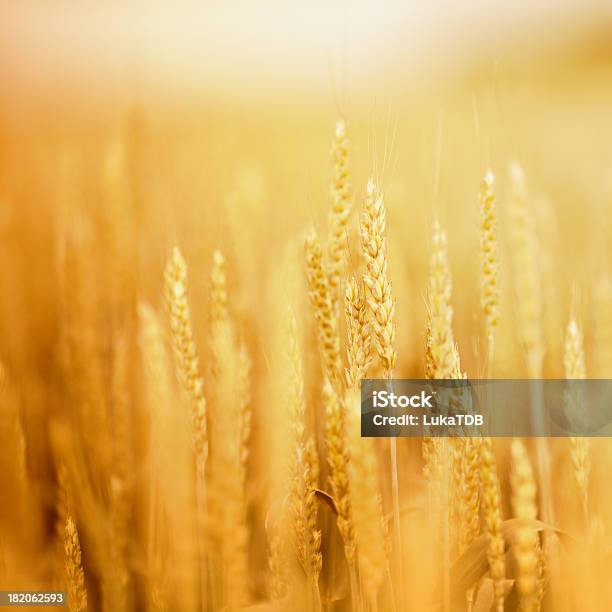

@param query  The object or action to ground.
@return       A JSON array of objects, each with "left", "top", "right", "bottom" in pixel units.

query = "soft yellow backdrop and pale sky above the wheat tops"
[{"left": 0, "top": 0, "right": 612, "bottom": 376}]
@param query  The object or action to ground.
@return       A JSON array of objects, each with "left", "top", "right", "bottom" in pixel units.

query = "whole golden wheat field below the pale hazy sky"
[{"left": 0, "top": 5, "right": 612, "bottom": 612}]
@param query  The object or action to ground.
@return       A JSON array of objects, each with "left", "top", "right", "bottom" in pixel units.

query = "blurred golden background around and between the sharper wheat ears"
[{"left": 0, "top": 0, "right": 612, "bottom": 612}]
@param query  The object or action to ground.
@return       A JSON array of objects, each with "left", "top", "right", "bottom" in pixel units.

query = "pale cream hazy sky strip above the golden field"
[{"left": 0, "top": 0, "right": 610, "bottom": 101}]
